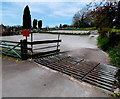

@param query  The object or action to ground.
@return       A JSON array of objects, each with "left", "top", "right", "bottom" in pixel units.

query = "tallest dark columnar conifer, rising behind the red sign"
[{"left": 23, "top": 5, "right": 31, "bottom": 29}]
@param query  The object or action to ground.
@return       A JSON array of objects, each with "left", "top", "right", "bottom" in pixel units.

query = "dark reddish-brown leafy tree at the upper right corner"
[{"left": 90, "top": 1, "right": 120, "bottom": 29}]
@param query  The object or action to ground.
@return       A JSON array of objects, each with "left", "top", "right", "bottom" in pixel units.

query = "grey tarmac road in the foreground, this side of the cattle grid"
[{"left": 2, "top": 59, "right": 109, "bottom": 97}]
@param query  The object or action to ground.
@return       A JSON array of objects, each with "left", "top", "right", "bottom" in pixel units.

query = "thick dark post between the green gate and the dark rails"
[{"left": 20, "top": 40, "right": 28, "bottom": 60}]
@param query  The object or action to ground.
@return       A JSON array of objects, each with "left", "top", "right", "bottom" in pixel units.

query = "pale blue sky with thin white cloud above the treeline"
[{"left": 0, "top": 0, "right": 92, "bottom": 27}]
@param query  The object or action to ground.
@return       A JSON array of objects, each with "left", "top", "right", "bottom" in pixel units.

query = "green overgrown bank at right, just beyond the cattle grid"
[{"left": 98, "top": 33, "right": 120, "bottom": 67}]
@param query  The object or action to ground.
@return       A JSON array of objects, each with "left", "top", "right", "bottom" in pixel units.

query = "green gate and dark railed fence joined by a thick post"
[{"left": 0, "top": 40, "right": 61, "bottom": 60}]
